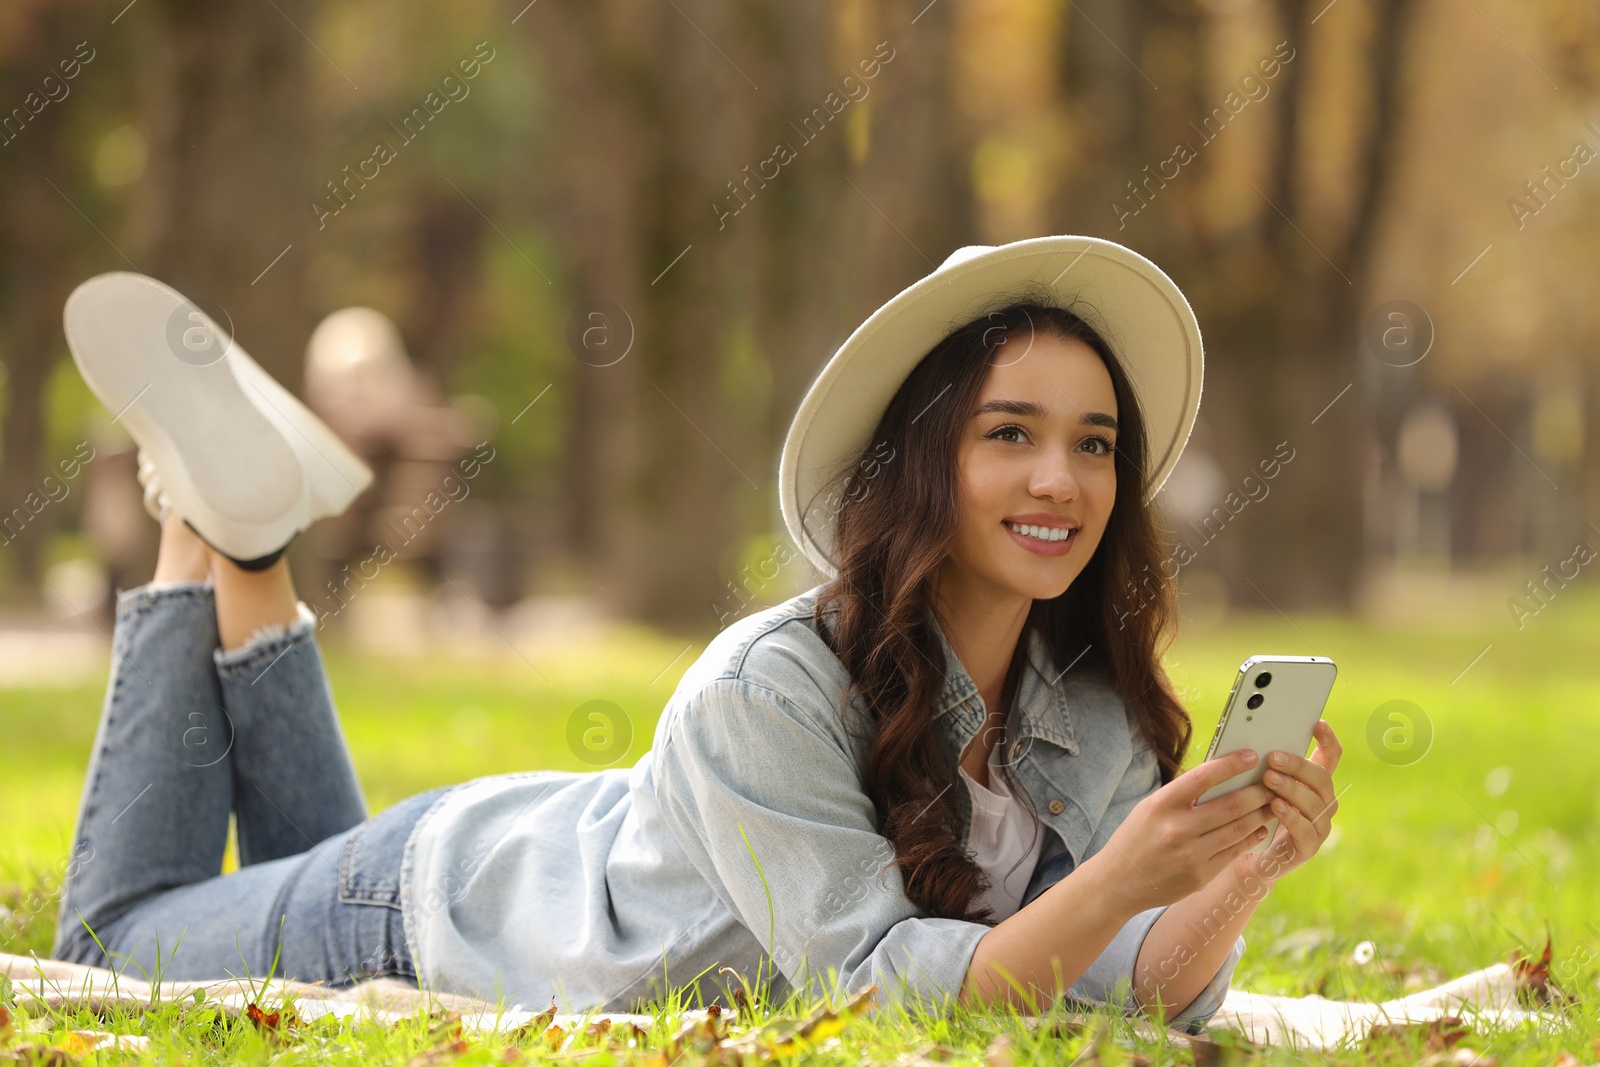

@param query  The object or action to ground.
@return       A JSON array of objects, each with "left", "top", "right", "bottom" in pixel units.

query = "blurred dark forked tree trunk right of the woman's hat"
[{"left": 1208, "top": 0, "right": 1413, "bottom": 609}]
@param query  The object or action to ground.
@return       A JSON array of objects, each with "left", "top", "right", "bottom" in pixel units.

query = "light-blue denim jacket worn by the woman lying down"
[{"left": 402, "top": 585, "right": 1245, "bottom": 1032}]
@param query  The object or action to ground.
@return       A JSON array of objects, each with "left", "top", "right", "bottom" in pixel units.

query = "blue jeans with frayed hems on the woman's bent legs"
[{"left": 54, "top": 582, "right": 445, "bottom": 985}]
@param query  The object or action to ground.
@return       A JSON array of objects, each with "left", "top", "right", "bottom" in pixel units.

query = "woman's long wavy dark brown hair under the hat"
[{"left": 814, "top": 293, "right": 1192, "bottom": 921}]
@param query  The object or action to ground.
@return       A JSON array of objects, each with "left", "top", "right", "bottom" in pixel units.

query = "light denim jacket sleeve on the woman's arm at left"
[{"left": 656, "top": 678, "right": 989, "bottom": 1001}]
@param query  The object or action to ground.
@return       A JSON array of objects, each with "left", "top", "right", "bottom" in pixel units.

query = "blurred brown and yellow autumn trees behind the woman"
[{"left": 0, "top": 0, "right": 1600, "bottom": 627}]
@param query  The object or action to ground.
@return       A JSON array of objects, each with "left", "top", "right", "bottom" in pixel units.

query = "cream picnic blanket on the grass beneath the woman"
[{"left": 0, "top": 953, "right": 1550, "bottom": 1049}]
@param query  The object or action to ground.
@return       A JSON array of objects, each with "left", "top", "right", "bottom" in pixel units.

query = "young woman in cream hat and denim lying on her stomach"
[{"left": 56, "top": 237, "right": 1339, "bottom": 1029}]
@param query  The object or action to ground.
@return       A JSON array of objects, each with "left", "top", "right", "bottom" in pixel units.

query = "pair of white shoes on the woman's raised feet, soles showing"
[{"left": 62, "top": 272, "right": 373, "bottom": 560}]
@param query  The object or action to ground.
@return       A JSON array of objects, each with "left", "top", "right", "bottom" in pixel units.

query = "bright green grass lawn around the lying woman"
[{"left": 0, "top": 589, "right": 1600, "bottom": 1064}]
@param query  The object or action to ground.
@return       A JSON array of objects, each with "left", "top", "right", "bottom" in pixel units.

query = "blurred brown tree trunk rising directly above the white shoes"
[{"left": 134, "top": 0, "right": 318, "bottom": 392}]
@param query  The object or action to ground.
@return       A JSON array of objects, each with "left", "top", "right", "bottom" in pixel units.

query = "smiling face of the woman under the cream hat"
[{"left": 946, "top": 333, "right": 1117, "bottom": 600}]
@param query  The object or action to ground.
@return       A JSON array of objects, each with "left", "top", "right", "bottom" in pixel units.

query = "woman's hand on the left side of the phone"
[{"left": 1093, "top": 750, "right": 1274, "bottom": 912}]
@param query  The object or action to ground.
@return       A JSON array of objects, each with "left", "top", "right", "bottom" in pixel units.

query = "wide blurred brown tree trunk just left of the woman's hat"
[{"left": 526, "top": 3, "right": 755, "bottom": 629}]
